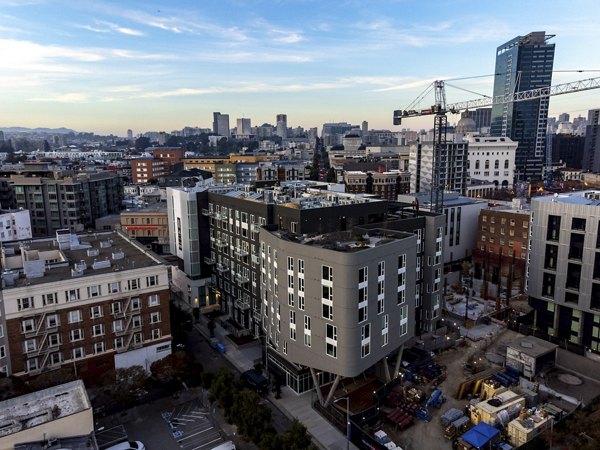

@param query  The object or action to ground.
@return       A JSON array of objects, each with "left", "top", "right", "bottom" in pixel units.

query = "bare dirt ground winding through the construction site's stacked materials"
[{"left": 384, "top": 330, "right": 514, "bottom": 450}]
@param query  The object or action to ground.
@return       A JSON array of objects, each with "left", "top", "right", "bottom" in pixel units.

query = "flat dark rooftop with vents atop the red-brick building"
[{"left": 0, "top": 230, "right": 162, "bottom": 289}]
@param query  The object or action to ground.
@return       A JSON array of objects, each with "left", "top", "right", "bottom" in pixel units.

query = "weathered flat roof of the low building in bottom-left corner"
[{"left": 0, "top": 380, "right": 92, "bottom": 437}]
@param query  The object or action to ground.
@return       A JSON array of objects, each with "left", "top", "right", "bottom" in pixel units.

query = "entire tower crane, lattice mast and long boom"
[{"left": 394, "top": 77, "right": 600, "bottom": 213}]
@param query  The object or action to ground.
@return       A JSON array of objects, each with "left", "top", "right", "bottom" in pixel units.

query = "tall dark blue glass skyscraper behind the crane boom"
[{"left": 491, "top": 31, "right": 554, "bottom": 180}]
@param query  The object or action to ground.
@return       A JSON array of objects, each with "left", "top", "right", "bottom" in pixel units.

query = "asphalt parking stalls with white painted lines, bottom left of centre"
[{"left": 161, "top": 400, "right": 224, "bottom": 450}]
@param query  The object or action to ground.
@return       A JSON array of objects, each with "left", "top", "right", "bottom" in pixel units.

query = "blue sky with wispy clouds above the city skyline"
[{"left": 0, "top": 0, "right": 600, "bottom": 136}]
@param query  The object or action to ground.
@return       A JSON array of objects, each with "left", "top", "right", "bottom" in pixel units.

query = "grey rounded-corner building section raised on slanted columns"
[{"left": 260, "top": 227, "right": 417, "bottom": 394}]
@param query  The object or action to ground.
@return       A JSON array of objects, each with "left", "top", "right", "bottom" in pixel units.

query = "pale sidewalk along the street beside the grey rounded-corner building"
[{"left": 185, "top": 306, "right": 357, "bottom": 450}]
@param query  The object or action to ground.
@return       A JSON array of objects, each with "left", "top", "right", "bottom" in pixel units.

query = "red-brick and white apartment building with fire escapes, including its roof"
[{"left": 0, "top": 230, "right": 171, "bottom": 380}]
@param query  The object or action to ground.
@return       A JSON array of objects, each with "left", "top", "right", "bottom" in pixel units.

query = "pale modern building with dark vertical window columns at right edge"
[{"left": 527, "top": 190, "right": 600, "bottom": 353}]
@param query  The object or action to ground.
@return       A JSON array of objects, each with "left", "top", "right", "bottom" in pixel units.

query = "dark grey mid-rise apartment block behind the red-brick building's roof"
[{"left": 10, "top": 172, "right": 123, "bottom": 237}]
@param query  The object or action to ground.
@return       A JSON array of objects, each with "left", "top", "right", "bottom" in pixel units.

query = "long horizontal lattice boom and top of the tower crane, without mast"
[{"left": 394, "top": 77, "right": 600, "bottom": 125}]
